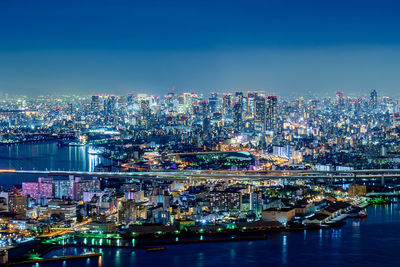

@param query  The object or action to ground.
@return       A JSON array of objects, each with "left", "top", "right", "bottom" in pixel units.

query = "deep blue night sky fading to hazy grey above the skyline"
[{"left": 0, "top": 0, "right": 400, "bottom": 95}]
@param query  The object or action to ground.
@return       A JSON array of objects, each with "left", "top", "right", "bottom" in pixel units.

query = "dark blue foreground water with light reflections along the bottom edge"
[{"left": 17, "top": 203, "right": 400, "bottom": 266}]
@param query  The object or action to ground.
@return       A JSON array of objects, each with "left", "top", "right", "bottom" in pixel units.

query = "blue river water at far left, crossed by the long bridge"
[{"left": 0, "top": 141, "right": 109, "bottom": 186}]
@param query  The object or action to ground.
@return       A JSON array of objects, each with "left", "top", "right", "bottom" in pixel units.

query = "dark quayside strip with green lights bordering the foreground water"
[{"left": 3, "top": 201, "right": 374, "bottom": 266}]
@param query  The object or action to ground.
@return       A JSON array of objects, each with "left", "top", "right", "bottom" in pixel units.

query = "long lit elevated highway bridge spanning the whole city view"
[{"left": 0, "top": 169, "right": 400, "bottom": 184}]
